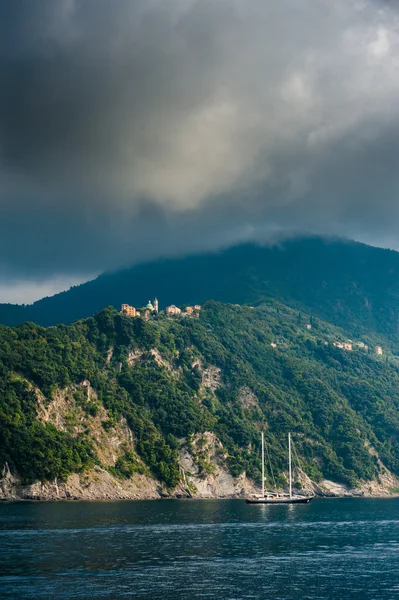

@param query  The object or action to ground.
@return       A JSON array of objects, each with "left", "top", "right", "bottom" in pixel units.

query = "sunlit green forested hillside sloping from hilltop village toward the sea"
[{"left": 0, "top": 301, "right": 399, "bottom": 488}]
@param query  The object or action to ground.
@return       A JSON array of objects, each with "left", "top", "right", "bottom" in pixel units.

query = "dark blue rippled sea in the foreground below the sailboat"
[{"left": 0, "top": 499, "right": 399, "bottom": 600}]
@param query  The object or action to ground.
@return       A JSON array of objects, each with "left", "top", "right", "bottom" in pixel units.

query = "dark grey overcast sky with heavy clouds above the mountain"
[{"left": 0, "top": 0, "right": 399, "bottom": 302}]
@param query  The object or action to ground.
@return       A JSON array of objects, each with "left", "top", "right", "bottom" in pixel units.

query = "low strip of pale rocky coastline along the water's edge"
[{"left": 0, "top": 467, "right": 399, "bottom": 503}]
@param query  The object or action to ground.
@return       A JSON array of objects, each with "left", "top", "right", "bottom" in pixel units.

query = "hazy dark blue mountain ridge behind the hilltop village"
[{"left": 0, "top": 237, "right": 399, "bottom": 349}]
